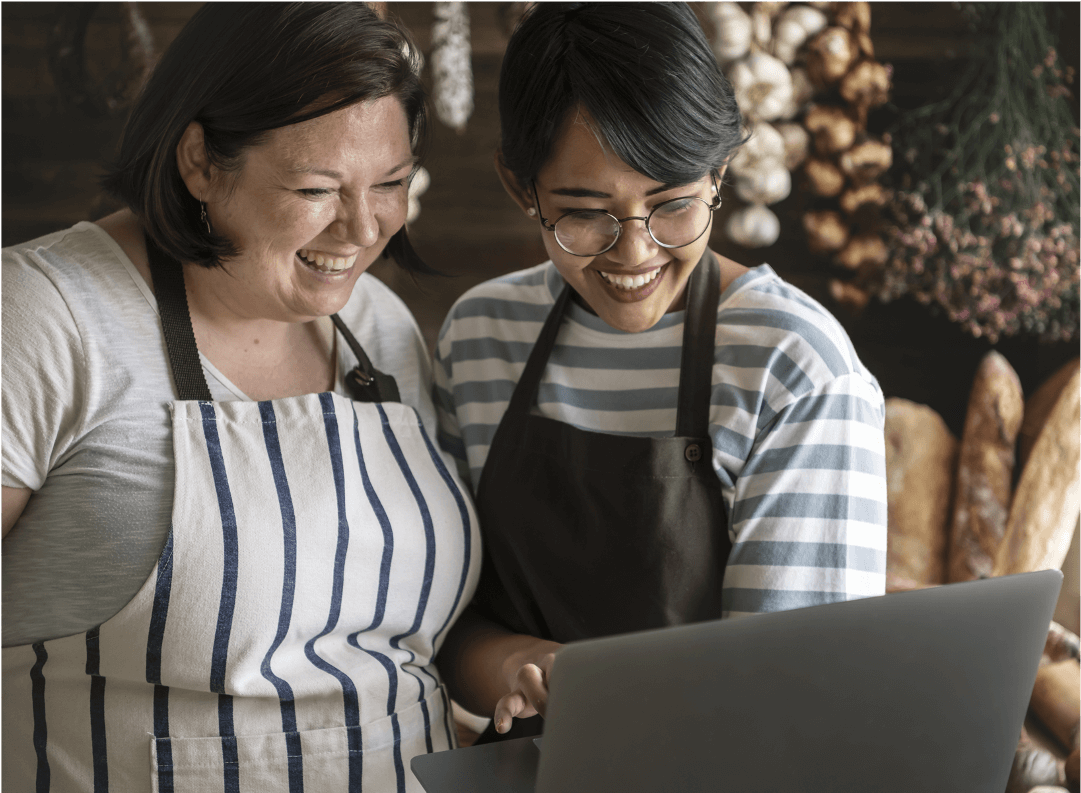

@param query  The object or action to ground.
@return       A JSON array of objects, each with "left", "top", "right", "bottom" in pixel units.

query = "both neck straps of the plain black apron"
[{"left": 507, "top": 248, "right": 721, "bottom": 438}]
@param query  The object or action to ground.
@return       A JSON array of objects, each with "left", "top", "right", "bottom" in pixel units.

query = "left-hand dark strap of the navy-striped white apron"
[{"left": 145, "top": 234, "right": 212, "bottom": 402}]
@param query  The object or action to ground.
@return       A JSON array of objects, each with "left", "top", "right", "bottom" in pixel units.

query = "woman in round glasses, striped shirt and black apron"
[{"left": 436, "top": 2, "right": 885, "bottom": 737}]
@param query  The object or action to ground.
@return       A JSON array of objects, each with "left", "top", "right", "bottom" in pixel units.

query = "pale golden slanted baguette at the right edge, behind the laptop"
[{"left": 992, "top": 369, "right": 1081, "bottom": 576}]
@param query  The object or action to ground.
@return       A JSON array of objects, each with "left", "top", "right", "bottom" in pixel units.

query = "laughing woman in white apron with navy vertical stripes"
[{"left": 0, "top": 2, "right": 479, "bottom": 793}]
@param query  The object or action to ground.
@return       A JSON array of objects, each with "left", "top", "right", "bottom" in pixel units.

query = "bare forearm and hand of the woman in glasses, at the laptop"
[{"left": 436, "top": 608, "right": 563, "bottom": 732}]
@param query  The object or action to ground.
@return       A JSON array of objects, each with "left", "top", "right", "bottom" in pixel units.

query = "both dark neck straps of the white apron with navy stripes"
[{"left": 145, "top": 230, "right": 401, "bottom": 402}]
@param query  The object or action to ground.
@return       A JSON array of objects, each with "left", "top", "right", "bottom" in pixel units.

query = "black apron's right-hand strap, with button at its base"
[{"left": 676, "top": 247, "right": 721, "bottom": 438}]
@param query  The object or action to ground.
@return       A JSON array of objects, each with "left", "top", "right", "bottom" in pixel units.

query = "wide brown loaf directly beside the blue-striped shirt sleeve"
[{"left": 885, "top": 398, "right": 957, "bottom": 592}]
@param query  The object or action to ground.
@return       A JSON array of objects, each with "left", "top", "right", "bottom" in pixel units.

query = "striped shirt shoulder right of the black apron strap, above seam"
[{"left": 717, "top": 265, "right": 881, "bottom": 406}]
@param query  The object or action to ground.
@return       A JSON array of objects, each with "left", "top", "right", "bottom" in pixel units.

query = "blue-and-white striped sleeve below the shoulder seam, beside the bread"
[{"left": 722, "top": 373, "right": 886, "bottom": 616}]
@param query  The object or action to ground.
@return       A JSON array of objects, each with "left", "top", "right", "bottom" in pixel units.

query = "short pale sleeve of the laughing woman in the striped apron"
[{"left": 0, "top": 251, "right": 86, "bottom": 490}]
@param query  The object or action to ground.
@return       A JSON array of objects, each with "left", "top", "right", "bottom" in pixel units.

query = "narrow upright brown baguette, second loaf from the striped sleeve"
[{"left": 947, "top": 350, "right": 1025, "bottom": 581}]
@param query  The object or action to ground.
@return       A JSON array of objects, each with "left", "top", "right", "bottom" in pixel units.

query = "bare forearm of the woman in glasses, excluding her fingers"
[{"left": 436, "top": 608, "right": 561, "bottom": 715}]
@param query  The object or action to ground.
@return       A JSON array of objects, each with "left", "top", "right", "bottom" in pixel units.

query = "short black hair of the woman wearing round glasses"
[{"left": 499, "top": 2, "right": 744, "bottom": 189}]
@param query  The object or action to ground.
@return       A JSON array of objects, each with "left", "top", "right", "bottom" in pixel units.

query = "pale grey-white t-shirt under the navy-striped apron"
[{"left": 0, "top": 223, "right": 436, "bottom": 646}]
